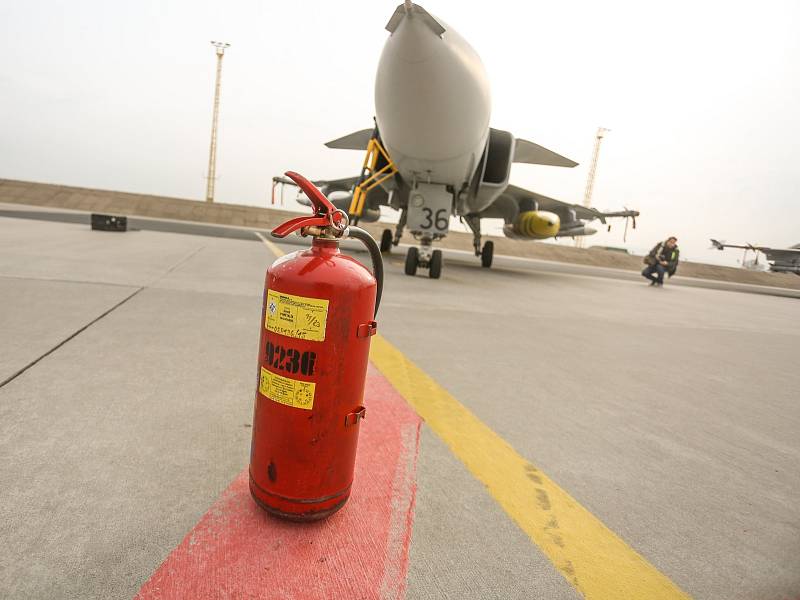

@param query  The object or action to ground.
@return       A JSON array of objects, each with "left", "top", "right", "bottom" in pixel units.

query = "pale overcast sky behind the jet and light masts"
[{"left": 0, "top": 0, "right": 800, "bottom": 264}]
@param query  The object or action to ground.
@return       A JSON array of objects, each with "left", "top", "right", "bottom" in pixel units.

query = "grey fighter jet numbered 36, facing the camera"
[{"left": 282, "top": 0, "right": 639, "bottom": 278}]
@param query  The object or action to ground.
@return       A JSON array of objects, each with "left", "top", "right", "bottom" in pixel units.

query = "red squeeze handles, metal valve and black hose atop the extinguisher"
[{"left": 272, "top": 171, "right": 383, "bottom": 316}]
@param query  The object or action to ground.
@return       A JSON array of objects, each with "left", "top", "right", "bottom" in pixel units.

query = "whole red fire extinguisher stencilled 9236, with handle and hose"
[{"left": 250, "top": 172, "right": 383, "bottom": 521}]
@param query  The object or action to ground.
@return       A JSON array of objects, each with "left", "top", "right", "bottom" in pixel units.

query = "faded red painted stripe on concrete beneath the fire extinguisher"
[{"left": 136, "top": 366, "right": 421, "bottom": 600}]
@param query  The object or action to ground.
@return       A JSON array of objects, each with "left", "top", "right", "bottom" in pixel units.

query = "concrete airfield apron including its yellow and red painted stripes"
[{"left": 0, "top": 217, "right": 800, "bottom": 600}]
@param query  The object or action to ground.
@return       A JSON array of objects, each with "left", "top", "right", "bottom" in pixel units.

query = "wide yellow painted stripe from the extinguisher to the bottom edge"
[{"left": 370, "top": 336, "right": 689, "bottom": 600}]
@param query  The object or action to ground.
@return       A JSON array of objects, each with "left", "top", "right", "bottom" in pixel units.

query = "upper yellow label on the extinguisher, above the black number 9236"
[{"left": 264, "top": 290, "right": 328, "bottom": 342}]
